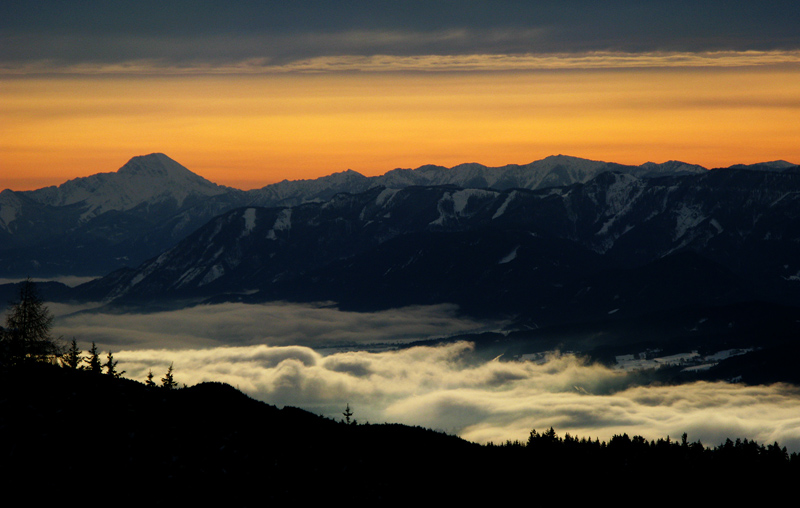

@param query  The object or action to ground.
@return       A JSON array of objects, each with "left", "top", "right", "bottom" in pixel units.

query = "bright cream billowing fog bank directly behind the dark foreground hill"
[{"left": 115, "top": 342, "right": 800, "bottom": 451}]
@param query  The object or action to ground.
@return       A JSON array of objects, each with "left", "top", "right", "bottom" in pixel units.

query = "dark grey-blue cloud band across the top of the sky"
[{"left": 0, "top": 0, "right": 800, "bottom": 66}]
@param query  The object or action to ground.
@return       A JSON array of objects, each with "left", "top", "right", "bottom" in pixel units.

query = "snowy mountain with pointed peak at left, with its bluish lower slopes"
[{"left": 0, "top": 154, "right": 241, "bottom": 276}]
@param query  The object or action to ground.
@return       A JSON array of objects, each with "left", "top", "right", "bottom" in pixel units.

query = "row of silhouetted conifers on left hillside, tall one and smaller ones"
[{"left": 0, "top": 278, "right": 178, "bottom": 389}]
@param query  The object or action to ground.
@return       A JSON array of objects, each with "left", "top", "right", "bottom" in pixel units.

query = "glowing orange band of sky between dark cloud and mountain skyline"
[{"left": 0, "top": 65, "right": 800, "bottom": 190}]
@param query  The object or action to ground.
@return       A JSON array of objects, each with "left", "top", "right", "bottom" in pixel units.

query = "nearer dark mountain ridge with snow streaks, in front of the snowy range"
[{"left": 79, "top": 170, "right": 800, "bottom": 321}]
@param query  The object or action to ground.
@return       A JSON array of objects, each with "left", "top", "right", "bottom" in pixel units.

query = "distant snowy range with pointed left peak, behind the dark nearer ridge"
[{"left": 0, "top": 154, "right": 796, "bottom": 276}]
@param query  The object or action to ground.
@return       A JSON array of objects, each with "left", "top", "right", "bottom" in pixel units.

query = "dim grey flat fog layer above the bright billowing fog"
[{"left": 51, "top": 303, "right": 501, "bottom": 350}]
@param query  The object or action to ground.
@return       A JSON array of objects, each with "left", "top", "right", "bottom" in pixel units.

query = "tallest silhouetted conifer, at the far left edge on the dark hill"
[{"left": 0, "top": 278, "right": 62, "bottom": 365}]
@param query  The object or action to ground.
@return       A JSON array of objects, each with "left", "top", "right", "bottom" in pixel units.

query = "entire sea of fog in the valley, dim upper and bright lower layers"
[{"left": 48, "top": 303, "right": 800, "bottom": 451}]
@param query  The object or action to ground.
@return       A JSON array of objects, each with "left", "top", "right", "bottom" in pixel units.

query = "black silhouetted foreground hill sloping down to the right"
[{"left": 0, "top": 365, "right": 800, "bottom": 506}]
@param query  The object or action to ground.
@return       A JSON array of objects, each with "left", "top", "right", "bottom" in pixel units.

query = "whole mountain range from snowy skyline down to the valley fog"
[{"left": 0, "top": 154, "right": 800, "bottom": 382}]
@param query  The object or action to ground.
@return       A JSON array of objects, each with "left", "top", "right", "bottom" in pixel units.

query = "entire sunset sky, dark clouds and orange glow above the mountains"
[{"left": 0, "top": 0, "right": 800, "bottom": 190}]
